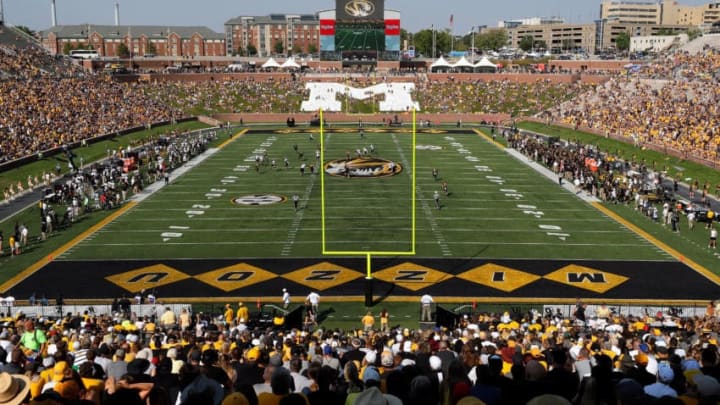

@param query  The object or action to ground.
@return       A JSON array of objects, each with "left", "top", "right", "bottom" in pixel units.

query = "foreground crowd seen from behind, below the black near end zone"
[{"left": 0, "top": 301, "right": 720, "bottom": 405}]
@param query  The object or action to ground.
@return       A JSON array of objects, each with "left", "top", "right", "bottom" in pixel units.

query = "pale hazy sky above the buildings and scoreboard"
[{"left": 0, "top": 0, "right": 709, "bottom": 34}]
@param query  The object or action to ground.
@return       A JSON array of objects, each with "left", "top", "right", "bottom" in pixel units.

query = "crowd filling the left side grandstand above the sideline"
[{"left": 0, "top": 43, "right": 183, "bottom": 163}]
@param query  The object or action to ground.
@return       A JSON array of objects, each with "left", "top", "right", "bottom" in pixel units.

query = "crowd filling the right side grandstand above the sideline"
[{"left": 549, "top": 49, "right": 720, "bottom": 161}]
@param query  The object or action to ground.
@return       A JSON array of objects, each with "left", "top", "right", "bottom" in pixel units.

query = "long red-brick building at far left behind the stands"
[{"left": 40, "top": 24, "right": 226, "bottom": 57}]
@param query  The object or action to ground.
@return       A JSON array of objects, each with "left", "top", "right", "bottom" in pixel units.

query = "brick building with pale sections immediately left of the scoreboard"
[{"left": 225, "top": 14, "right": 320, "bottom": 57}]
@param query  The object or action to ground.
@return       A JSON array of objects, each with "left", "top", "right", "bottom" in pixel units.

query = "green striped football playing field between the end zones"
[{"left": 58, "top": 130, "right": 674, "bottom": 261}]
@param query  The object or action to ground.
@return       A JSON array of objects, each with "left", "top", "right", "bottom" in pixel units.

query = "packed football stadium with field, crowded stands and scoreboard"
[{"left": 0, "top": 0, "right": 720, "bottom": 405}]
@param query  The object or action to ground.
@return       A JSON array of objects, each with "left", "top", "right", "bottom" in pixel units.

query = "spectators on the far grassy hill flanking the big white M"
[{"left": 149, "top": 76, "right": 584, "bottom": 115}]
